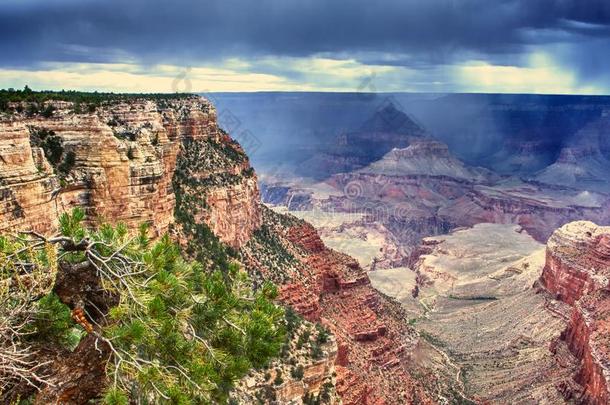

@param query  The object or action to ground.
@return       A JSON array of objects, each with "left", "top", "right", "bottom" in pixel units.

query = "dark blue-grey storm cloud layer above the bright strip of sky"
[{"left": 0, "top": 0, "right": 610, "bottom": 85}]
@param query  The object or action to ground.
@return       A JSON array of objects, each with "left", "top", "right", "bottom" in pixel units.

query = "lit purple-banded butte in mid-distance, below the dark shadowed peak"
[{"left": 262, "top": 140, "right": 610, "bottom": 274}]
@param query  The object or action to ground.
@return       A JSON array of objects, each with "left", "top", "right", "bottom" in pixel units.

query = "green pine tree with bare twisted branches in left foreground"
[{"left": 0, "top": 210, "right": 285, "bottom": 404}]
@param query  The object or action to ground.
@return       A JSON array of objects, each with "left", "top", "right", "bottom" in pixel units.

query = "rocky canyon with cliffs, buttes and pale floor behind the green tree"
[{"left": 0, "top": 92, "right": 610, "bottom": 405}]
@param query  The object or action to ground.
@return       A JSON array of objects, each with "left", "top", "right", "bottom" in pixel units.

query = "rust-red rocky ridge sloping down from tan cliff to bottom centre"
[{"left": 241, "top": 208, "right": 433, "bottom": 405}]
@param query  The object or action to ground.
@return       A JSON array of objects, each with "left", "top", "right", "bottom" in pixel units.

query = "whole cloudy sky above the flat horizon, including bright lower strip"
[{"left": 0, "top": 0, "right": 610, "bottom": 94}]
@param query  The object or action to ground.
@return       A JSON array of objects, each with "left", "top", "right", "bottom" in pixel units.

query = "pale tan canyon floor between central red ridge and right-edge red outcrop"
[{"left": 282, "top": 211, "right": 577, "bottom": 404}]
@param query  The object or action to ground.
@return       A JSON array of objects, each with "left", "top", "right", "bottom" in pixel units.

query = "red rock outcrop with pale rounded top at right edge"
[{"left": 541, "top": 221, "right": 610, "bottom": 405}]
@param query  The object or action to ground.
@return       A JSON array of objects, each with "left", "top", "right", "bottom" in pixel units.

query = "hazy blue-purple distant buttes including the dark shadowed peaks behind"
[{"left": 262, "top": 101, "right": 610, "bottom": 269}]
